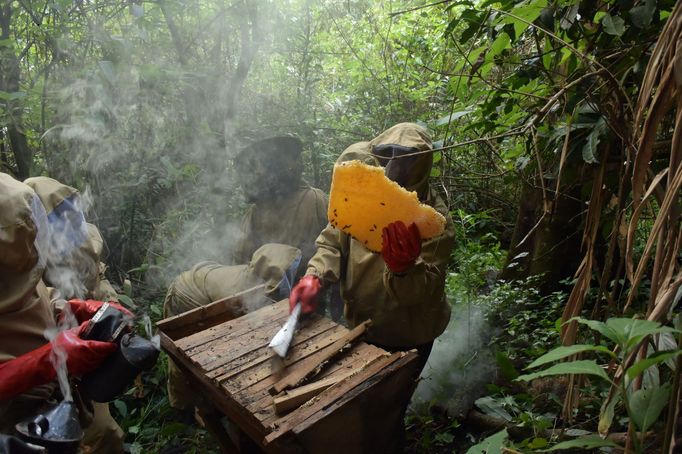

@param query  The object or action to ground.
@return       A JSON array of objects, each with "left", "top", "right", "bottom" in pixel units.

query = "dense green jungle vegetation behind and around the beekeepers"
[{"left": 0, "top": 0, "right": 682, "bottom": 453}]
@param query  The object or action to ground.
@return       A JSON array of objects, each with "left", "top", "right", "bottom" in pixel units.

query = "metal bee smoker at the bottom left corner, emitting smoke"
[{"left": 15, "top": 400, "right": 83, "bottom": 454}]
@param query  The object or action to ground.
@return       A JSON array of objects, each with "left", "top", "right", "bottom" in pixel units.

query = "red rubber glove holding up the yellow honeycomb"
[{"left": 381, "top": 221, "right": 422, "bottom": 273}]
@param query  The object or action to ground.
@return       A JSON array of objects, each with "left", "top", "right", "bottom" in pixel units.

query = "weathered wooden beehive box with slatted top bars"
[{"left": 158, "top": 287, "right": 416, "bottom": 453}]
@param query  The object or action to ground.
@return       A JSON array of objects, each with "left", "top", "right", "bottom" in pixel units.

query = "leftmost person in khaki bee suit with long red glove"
[{"left": 0, "top": 173, "right": 123, "bottom": 453}]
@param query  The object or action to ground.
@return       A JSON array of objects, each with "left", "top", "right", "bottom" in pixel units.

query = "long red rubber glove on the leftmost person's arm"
[{"left": 0, "top": 322, "right": 118, "bottom": 401}]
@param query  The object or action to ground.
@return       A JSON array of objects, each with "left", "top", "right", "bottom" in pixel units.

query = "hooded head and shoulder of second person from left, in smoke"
[{"left": 25, "top": 177, "right": 102, "bottom": 298}]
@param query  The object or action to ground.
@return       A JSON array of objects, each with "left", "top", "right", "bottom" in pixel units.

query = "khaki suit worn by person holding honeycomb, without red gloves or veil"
[{"left": 306, "top": 123, "right": 455, "bottom": 348}]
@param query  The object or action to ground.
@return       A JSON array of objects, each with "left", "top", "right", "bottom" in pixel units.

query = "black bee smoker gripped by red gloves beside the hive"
[{"left": 80, "top": 303, "right": 159, "bottom": 402}]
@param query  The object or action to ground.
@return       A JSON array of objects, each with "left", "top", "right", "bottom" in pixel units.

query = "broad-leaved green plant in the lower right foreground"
[{"left": 468, "top": 317, "right": 682, "bottom": 454}]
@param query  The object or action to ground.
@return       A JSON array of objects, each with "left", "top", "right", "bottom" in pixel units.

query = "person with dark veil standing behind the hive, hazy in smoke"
[{"left": 234, "top": 136, "right": 327, "bottom": 263}]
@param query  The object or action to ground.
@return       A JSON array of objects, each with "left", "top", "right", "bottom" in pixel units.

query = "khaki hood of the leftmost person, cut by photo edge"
[{"left": 0, "top": 173, "right": 46, "bottom": 312}]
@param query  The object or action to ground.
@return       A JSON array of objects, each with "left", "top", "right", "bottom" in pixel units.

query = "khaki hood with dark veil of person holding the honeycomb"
[{"left": 337, "top": 123, "right": 433, "bottom": 200}]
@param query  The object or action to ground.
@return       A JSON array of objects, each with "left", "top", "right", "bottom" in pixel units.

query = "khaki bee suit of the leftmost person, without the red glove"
[{"left": 0, "top": 173, "right": 123, "bottom": 454}]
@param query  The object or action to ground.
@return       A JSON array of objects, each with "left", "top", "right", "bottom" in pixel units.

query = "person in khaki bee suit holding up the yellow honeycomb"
[{"left": 290, "top": 123, "right": 454, "bottom": 452}]
